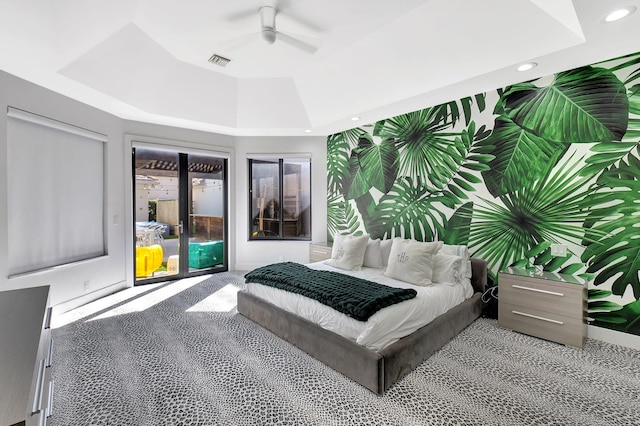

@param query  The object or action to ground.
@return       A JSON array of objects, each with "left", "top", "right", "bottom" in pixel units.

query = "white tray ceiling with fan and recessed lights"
[{"left": 0, "top": 0, "right": 640, "bottom": 135}]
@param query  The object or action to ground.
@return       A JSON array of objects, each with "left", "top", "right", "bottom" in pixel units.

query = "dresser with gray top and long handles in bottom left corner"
[{"left": 0, "top": 286, "right": 53, "bottom": 426}]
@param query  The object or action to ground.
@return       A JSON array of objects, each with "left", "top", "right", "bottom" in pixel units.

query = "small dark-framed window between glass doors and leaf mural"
[{"left": 249, "top": 158, "right": 311, "bottom": 240}]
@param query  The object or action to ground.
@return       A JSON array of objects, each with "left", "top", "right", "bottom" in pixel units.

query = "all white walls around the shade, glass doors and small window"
[{"left": 0, "top": 71, "right": 326, "bottom": 312}]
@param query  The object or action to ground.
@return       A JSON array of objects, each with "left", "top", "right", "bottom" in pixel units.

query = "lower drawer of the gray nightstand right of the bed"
[{"left": 498, "top": 302, "right": 586, "bottom": 347}]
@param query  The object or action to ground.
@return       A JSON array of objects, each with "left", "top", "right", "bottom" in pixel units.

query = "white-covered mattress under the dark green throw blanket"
[{"left": 247, "top": 262, "right": 473, "bottom": 351}]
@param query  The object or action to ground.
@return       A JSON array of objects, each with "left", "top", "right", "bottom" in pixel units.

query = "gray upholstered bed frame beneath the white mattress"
[{"left": 238, "top": 259, "right": 487, "bottom": 394}]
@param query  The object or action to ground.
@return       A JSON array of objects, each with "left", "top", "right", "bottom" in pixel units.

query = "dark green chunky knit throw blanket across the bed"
[{"left": 244, "top": 262, "right": 416, "bottom": 321}]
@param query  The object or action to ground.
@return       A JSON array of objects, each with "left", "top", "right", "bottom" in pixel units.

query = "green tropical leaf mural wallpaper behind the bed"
[{"left": 327, "top": 53, "right": 640, "bottom": 335}]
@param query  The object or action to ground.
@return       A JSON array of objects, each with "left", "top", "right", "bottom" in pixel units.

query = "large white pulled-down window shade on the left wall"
[{"left": 7, "top": 108, "right": 107, "bottom": 275}]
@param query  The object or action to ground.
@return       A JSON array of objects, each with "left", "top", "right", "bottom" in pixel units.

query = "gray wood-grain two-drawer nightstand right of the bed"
[{"left": 498, "top": 268, "right": 587, "bottom": 348}]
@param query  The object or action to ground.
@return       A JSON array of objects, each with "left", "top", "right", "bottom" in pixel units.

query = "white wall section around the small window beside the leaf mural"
[{"left": 231, "top": 136, "right": 327, "bottom": 271}]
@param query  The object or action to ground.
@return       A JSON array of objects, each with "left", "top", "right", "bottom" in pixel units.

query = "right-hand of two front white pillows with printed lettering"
[{"left": 384, "top": 238, "right": 442, "bottom": 286}]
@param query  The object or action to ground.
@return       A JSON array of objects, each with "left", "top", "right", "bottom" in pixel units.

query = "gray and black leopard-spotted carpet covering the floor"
[{"left": 51, "top": 273, "right": 640, "bottom": 426}]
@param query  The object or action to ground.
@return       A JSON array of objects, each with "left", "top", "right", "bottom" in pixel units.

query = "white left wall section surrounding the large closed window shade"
[{"left": 0, "top": 71, "right": 128, "bottom": 305}]
